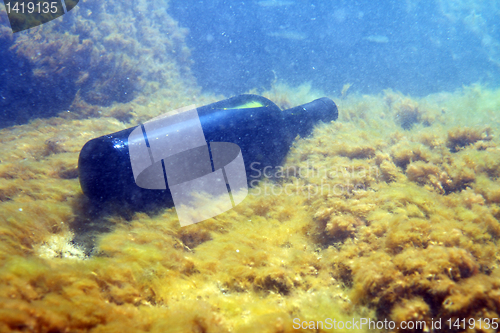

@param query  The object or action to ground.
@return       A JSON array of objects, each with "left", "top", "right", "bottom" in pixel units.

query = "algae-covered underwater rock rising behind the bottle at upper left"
[{"left": 0, "top": 0, "right": 195, "bottom": 127}]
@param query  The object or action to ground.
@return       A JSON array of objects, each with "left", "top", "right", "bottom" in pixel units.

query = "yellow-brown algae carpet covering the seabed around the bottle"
[{"left": 0, "top": 82, "right": 500, "bottom": 332}]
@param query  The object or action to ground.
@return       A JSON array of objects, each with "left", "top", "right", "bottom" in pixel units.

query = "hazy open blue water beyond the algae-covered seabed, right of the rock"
[{"left": 171, "top": 0, "right": 500, "bottom": 95}]
